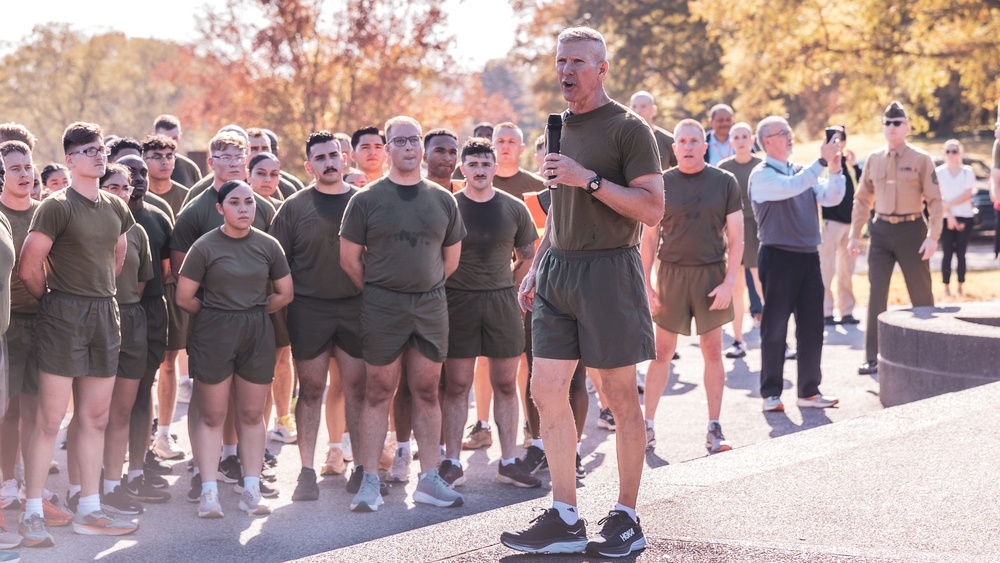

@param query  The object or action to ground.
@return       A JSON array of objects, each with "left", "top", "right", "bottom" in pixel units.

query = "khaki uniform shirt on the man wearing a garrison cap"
[{"left": 851, "top": 144, "right": 944, "bottom": 240}]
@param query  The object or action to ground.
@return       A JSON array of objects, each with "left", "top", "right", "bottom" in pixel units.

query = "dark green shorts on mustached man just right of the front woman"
[{"left": 288, "top": 295, "right": 363, "bottom": 360}]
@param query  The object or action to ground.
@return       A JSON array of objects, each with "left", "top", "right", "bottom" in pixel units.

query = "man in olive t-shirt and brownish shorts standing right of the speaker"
[{"left": 642, "top": 119, "right": 743, "bottom": 454}]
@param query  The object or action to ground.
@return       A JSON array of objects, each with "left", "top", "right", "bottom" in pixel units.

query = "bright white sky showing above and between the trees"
[{"left": 2, "top": 0, "right": 515, "bottom": 70}]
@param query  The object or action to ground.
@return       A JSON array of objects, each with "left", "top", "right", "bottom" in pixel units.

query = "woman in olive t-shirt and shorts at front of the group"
[{"left": 177, "top": 182, "right": 293, "bottom": 518}]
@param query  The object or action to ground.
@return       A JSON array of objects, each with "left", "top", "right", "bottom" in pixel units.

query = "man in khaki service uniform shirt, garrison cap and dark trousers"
[{"left": 847, "top": 101, "right": 944, "bottom": 375}]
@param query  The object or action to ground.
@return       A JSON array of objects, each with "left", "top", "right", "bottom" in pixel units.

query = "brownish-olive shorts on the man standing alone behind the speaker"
[{"left": 653, "top": 262, "right": 733, "bottom": 336}]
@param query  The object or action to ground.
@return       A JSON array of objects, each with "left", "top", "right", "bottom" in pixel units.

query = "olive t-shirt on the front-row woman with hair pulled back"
[{"left": 180, "top": 228, "right": 289, "bottom": 310}]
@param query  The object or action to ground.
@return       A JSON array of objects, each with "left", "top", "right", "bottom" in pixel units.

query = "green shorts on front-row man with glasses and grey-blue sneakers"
[{"left": 361, "top": 284, "right": 448, "bottom": 366}]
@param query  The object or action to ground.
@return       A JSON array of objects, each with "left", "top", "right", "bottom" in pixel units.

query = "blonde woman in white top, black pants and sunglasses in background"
[{"left": 935, "top": 139, "right": 976, "bottom": 296}]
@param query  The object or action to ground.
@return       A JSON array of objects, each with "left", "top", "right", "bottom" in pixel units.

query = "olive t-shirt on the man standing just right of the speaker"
[{"left": 657, "top": 165, "right": 742, "bottom": 266}]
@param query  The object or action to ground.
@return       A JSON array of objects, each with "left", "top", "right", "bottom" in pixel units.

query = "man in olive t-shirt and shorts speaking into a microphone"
[{"left": 500, "top": 28, "right": 663, "bottom": 556}]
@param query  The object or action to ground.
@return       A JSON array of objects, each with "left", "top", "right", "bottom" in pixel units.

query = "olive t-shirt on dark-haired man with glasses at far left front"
[{"left": 29, "top": 187, "right": 135, "bottom": 299}]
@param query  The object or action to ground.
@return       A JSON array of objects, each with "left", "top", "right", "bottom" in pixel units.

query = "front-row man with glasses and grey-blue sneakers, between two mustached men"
[{"left": 340, "top": 116, "right": 465, "bottom": 511}]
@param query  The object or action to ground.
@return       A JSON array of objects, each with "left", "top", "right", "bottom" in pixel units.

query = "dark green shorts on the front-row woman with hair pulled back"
[{"left": 187, "top": 307, "right": 275, "bottom": 385}]
